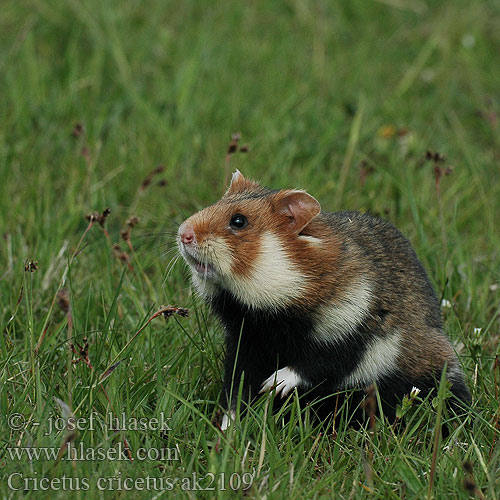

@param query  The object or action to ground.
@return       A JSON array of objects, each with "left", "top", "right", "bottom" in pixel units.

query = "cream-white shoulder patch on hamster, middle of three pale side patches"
[{"left": 314, "top": 281, "right": 372, "bottom": 343}]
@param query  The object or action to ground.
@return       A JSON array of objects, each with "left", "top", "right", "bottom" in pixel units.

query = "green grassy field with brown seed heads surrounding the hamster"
[{"left": 0, "top": 0, "right": 500, "bottom": 499}]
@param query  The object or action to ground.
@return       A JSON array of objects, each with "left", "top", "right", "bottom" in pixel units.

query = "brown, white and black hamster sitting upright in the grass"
[{"left": 177, "top": 171, "right": 471, "bottom": 429}]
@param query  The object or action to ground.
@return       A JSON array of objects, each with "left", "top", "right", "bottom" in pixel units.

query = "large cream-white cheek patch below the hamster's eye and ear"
[{"left": 226, "top": 233, "right": 306, "bottom": 310}]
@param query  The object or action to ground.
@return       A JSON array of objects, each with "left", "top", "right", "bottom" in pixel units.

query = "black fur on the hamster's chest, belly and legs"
[{"left": 211, "top": 292, "right": 470, "bottom": 421}]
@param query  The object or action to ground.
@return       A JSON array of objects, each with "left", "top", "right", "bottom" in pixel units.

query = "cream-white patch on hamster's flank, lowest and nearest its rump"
[{"left": 342, "top": 330, "right": 401, "bottom": 389}]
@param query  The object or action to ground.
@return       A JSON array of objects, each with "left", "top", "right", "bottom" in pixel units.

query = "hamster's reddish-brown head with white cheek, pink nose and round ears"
[{"left": 177, "top": 171, "right": 335, "bottom": 310}]
